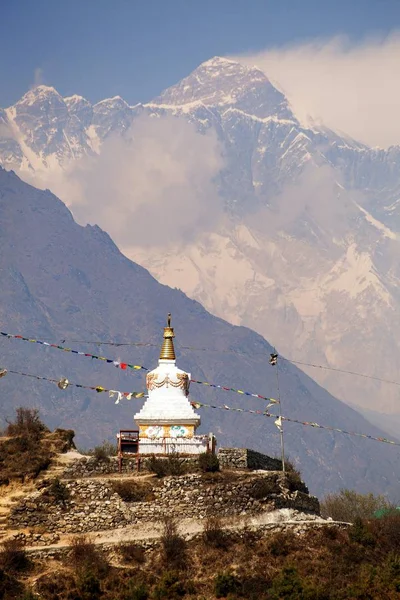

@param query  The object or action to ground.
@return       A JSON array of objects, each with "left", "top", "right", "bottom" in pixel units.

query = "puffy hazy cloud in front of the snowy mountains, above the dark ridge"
[{"left": 29, "top": 116, "right": 223, "bottom": 248}]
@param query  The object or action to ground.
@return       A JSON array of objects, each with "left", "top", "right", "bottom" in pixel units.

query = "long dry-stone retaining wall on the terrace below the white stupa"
[{"left": 8, "top": 472, "right": 319, "bottom": 533}]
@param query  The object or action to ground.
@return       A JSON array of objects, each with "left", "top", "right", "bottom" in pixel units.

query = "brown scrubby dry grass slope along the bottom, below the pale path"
[{"left": 6, "top": 515, "right": 400, "bottom": 600}]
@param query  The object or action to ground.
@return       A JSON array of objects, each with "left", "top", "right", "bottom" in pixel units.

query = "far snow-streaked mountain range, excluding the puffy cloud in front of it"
[{"left": 0, "top": 57, "right": 400, "bottom": 422}]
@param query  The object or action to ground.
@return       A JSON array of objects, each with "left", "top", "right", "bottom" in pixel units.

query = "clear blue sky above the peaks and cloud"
[{"left": 0, "top": 0, "right": 400, "bottom": 107}]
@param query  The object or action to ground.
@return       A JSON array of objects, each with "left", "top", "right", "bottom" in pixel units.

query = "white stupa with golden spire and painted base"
[{"left": 134, "top": 314, "right": 214, "bottom": 454}]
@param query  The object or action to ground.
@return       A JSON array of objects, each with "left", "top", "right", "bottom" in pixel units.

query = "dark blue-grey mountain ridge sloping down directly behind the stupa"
[{"left": 0, "top": 167, "right": 400, "bottom": 498}]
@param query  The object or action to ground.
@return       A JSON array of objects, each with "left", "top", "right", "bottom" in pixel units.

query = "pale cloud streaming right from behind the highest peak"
[{"left": 236, "top": 32, "right": 400, "bottom": 147}]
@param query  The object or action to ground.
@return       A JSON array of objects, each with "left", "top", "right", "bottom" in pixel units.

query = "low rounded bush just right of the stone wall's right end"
[{"left": 321, "top": 490, "right": 392, "bottom": 523}]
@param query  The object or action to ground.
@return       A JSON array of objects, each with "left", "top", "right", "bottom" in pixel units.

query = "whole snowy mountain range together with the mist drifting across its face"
[{"left": 0, "top": 57, "right": 400, "bottom": 422}]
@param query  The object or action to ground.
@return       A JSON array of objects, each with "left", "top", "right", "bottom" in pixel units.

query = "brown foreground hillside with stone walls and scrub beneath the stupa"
[{"left": 0, "top": 432, "right": 400, "bottom": 600}]
